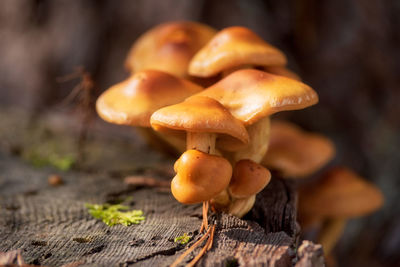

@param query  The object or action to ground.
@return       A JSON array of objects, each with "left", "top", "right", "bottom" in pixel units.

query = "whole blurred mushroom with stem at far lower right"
[{"left": 299, "top": 167, "right": 383, "bottom": 255}]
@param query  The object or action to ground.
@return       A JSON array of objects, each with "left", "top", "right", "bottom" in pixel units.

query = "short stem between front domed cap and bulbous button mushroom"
[{"left": 186, "top": 132, "right": 217, "bottom": 155}]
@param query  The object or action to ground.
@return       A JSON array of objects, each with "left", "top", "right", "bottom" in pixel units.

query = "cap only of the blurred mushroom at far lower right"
[{"left": 299, "top": 167, "right": 383, "bottom": 218}]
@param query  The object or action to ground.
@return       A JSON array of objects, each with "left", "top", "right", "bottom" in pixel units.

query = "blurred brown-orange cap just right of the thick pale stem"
[{"left": 261, "top": 120, "right": 335, "bottom": 178}]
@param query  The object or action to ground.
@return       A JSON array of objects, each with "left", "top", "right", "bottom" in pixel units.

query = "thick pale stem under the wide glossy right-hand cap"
[{"left": 233, "top": 117, "right": 271, "bottom": 163}]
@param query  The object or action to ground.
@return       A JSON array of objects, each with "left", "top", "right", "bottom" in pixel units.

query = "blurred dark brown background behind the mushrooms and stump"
[{"left": 0, "top": 0, "right": 400, "bottom": 266}]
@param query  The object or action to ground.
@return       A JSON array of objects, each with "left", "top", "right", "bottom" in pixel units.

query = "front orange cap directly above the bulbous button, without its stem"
[{"left": 151, "top": 96, "right": 249, "bottom": 147}]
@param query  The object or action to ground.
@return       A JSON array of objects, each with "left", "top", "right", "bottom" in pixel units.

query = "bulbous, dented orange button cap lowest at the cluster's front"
[{"left": 171, "top": 150, "right": 232, "bottom": 204}]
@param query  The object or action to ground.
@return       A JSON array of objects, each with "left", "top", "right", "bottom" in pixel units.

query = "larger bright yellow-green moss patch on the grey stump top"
[{"left": 85, "top": 204, "right": 145, "bottom": 226}]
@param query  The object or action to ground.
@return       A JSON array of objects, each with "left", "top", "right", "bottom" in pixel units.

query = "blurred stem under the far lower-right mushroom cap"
[{"left": 317, "top": 218, "right": 346, "bottom": 255}]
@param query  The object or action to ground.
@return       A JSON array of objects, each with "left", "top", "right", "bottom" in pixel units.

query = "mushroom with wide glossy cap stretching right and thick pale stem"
[{"left": 189, "top": 69, "right": 318, "bottom": 163}]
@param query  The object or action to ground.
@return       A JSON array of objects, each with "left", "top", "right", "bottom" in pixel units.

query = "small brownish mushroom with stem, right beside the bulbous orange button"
[{"left": 228, "top": 159, "right": 271, "bottom": 218}]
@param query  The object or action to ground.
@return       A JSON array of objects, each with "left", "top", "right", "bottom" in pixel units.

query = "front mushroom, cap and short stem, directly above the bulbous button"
[{"left": 151, "top": 96, "right": 249, "bottom": 211}]
